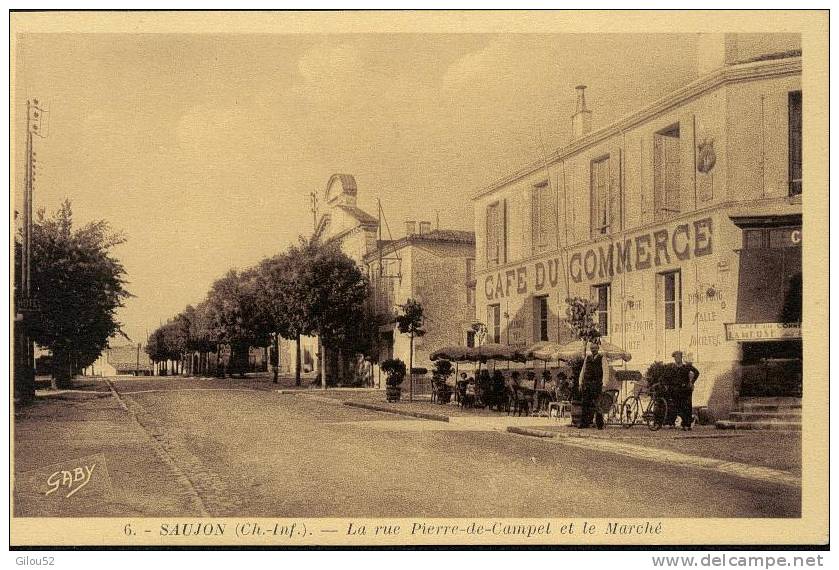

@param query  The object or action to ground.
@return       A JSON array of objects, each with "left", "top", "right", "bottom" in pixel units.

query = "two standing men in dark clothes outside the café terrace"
[{"left": 577, "top": 342, "right": 699, "bottom": 431}]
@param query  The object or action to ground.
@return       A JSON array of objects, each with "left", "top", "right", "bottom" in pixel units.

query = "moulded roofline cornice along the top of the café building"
[{"left": 472, "top": 57, "right": 801, "bottom": 200}]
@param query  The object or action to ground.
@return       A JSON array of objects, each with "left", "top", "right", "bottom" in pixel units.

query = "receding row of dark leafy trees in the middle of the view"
[{"left": 146, "top": 233, "right": 378, "bottom": 385}]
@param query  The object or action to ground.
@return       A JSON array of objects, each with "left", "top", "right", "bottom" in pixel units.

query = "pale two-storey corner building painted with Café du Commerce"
[{"left": 473, "top": 34, "right": 803, "bottom": 418}]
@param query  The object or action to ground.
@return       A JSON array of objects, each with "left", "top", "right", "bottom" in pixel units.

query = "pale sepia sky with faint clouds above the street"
[{"left": 13, "top": 33, "right": 696, "bottom": 342}]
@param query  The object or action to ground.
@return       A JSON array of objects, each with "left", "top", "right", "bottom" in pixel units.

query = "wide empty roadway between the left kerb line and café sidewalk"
[{"left": 101, "top": 379, "right": 801, "bottom": 517}]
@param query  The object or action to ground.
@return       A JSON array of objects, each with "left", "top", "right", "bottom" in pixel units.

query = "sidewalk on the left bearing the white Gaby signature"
[{"left": 14, "top": 379, "right": 205, "bottom": 517}]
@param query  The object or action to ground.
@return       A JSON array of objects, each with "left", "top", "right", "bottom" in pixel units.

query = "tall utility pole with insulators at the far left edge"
[{"left": 14, "top": 99, "right": 44, "bottom": 402}]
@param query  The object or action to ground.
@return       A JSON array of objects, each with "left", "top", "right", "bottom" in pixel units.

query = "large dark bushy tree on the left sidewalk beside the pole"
[{"left": 26, "top": 200, "right": 131, "bottom": 386}]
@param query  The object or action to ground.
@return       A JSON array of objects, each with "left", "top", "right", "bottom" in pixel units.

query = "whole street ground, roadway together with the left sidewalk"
[{"left": 15, "top": 377, "right": 801, "bottom": 518}]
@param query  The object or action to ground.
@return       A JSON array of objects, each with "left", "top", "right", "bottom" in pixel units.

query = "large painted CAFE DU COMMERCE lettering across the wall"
[{"left": 484, "top": 218, "right": 714, "bottom": 301}]
